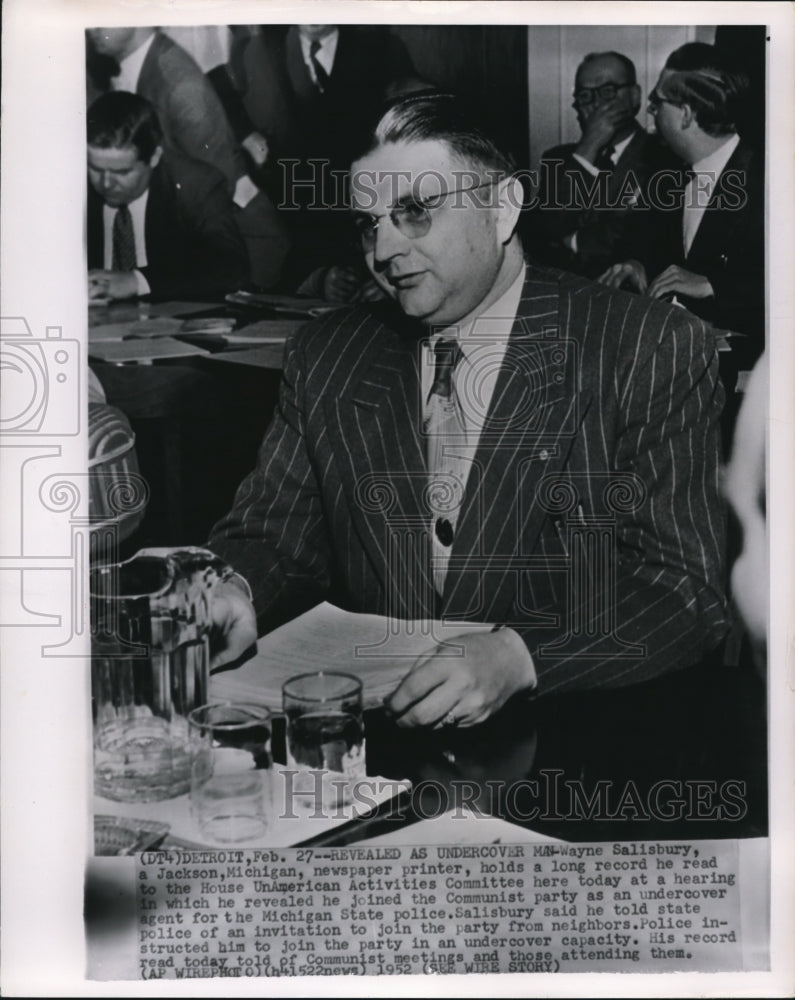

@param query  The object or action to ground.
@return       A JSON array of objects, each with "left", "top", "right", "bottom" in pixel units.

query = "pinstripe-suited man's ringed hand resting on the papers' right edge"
[{"left": 385, "top": 629, "right": 536, "bottom": 726}]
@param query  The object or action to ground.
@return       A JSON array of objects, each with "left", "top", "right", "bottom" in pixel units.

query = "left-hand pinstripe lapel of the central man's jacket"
[{"left": 326, "top": 318, "right": 434, "bottom": 618}]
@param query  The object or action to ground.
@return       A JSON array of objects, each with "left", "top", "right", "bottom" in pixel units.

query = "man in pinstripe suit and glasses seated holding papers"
[{"left": 210, "top": 95, "right": 726, "bottom": 726}]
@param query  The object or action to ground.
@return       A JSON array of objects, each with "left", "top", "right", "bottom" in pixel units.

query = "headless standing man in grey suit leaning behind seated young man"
[{"left": 87, "top": 27, "right": 289, "bottom": 288}]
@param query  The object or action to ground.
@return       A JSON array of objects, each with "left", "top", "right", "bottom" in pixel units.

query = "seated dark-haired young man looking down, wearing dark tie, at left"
[{"left": 87, "top": 91, "right": 247, "bottom": 299}]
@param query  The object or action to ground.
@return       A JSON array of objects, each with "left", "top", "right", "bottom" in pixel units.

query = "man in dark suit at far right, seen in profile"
[{"left": 600, "top": 42, "right": 765, "bottom": 356}]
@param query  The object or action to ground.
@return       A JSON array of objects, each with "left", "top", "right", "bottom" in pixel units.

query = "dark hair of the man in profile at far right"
[{"left": 665, "top": 42, "right": 749, "bottom": 136}]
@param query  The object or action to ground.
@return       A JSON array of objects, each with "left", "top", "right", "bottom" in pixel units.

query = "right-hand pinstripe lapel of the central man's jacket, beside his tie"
[{"left": 442, "top": 273, "right": 582, "bottom": 621}]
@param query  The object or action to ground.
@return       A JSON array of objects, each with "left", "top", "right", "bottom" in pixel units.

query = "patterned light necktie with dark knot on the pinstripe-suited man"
[{"left": 430, "top": 339, "right": 466, "bottom": 594}]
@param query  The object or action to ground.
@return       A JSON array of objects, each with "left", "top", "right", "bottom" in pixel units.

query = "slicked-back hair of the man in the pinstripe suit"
[{"left": 354, "top": 92, "right": 516, "bottom": 174}]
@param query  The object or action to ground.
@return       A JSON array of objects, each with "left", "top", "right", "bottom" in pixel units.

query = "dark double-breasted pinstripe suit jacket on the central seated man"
[{"left": 209, "top": 267, "right": 726, "bottom": 693}]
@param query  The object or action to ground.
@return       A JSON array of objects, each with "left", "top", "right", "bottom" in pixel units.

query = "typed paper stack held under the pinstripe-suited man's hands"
[{"left": 210, "top": 603, "right": 491, "bottom": 711}]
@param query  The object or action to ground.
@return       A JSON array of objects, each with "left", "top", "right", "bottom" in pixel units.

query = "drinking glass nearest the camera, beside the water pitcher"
[{"left": 188, "top": 702, "right": 272, "bottom": 844}]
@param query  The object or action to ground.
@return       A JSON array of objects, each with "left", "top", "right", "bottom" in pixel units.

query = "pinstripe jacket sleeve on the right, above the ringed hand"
[{"left": 517, "top": 307, "right": 728, "bottom": 695}]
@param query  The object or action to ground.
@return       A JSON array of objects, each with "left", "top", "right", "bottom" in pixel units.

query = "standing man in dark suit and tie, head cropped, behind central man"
[{"left": 231, "top": 24, "right": 415, "bottom": 301}]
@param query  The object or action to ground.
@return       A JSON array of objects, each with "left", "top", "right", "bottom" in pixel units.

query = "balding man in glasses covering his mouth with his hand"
[{"left": 524, "top": 52, "right": 674, "bottom": 278}]
